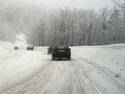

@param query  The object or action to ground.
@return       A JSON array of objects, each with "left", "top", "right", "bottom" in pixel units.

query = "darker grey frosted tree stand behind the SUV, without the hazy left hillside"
[{"left": 28, "top": 2, "right": 125, "bottom": 46}]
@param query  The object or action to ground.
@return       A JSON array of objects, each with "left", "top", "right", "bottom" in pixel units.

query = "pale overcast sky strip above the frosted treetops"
[{"left": 0, "top": 0, "right": 112, "bottom": 10}]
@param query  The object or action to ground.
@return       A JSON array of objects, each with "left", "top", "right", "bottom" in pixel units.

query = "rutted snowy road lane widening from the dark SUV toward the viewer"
[{"left": 3, "top": 57, "right": 101, "bottom": 94}]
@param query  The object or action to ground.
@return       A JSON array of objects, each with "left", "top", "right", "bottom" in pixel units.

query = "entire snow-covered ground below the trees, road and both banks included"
[{"left": 0, "top": 43, "right": 125, "bottom": 94}]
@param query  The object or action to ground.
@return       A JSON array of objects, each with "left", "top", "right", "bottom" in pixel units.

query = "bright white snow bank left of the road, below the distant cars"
[{"left": 0, "top": 42, "right": 50, "bottom": 92}]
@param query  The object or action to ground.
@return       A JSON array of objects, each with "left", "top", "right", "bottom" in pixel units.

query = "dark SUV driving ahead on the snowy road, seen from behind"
[{"left": 52, "top": 47, "right": 71, "bottom": 60}]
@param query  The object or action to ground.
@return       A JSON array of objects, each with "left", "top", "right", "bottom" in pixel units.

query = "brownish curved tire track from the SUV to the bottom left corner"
[{"left": 2, "top": 61, "right": 55, "bottom": 94}]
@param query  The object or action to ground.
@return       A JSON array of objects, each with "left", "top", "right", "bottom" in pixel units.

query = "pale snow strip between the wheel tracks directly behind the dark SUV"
[{"left": 40, "top": 61, "right": 72, "bottom": 94}]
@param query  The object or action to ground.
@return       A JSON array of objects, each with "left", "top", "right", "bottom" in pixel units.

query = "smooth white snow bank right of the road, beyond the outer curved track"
[{"left": 72, "top": 44, "right": 125, "bottom": 86}]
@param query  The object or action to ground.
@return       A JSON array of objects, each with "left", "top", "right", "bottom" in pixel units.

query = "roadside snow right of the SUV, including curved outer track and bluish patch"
[{"left": 72, "top": 44, "right": 125, "bottom": 94}]
